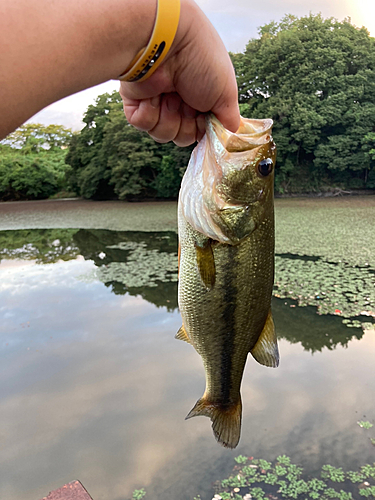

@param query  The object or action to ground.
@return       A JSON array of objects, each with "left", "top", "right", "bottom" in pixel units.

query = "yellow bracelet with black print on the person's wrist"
[{"left": 118, "top": 0, "right": 180, "bottom": 82}]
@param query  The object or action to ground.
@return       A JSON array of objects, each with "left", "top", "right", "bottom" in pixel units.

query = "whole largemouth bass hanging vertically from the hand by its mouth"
[{"left": 176, "top": 114, "right": 279, "bottom": 448}]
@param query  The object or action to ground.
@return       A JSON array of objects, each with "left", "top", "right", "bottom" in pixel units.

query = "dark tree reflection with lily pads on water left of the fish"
[{"left": 0, "top": 229, "right": 178, "bottom": 311}]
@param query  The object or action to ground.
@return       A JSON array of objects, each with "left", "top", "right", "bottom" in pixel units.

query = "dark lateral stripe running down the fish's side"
[{"left": 220, "top": 245, "right": 237, "bottom": 404}]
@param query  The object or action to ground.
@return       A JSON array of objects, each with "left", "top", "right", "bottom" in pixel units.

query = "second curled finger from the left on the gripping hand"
[{"left": 148, "top": 93, "right": 181, "bottom": 143}]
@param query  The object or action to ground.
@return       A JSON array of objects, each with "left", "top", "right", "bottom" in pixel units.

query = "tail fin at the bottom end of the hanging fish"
[{"left": 185, "top": 396, "right": 242, "bottom": 448}]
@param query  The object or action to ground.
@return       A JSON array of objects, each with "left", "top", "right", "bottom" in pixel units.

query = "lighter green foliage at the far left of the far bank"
[{"left": 0, "top": 123, "right": 72, "bottom": 200}]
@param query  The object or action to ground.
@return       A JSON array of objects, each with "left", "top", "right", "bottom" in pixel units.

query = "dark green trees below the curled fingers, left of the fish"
[{"left": 66, "top": 92, "right": 192, "bottom": 200}]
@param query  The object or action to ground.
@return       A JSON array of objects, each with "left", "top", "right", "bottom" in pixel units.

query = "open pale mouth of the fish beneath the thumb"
[{"left": 207, "top": 113, "right": 273, "bottom": 153}]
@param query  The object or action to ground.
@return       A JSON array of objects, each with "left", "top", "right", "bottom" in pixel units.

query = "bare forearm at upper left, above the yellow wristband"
[{"left": 0, "top": 0, "right": 156, "bottom": 138}]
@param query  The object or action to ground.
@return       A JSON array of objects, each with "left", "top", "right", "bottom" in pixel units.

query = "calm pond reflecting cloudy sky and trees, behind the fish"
[{"left": 0, "top": 197, "right": 375, "bottom": 500}]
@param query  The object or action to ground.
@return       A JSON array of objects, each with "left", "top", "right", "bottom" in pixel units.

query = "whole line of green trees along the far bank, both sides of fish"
[{"left": 0, "top": 14, "right": 375, "bottom": 200}]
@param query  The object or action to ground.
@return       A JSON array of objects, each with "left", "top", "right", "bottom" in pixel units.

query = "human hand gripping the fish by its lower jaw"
[{"left": 120, "top": 0, "right": 240, "bottom": 146}]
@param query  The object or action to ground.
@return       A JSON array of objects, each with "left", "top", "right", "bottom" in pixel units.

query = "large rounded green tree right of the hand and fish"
[{"left": 231, "top": 14, "right": 375, "bottom": 192}]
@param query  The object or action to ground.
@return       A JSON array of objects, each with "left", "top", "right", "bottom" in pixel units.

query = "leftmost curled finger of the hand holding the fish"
[{"left": 123, "top": 96, "right": 160, "bottom": 132}]
